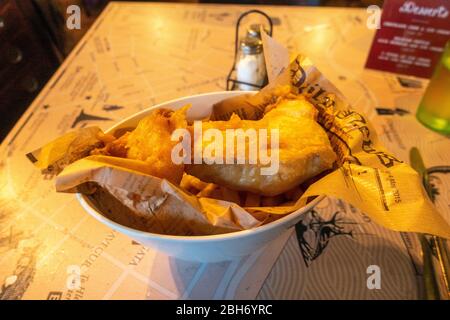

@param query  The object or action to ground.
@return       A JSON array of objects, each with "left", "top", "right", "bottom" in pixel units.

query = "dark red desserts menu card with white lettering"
[{"left": 366, "top": 0, "right": 450, "bottom": 78}]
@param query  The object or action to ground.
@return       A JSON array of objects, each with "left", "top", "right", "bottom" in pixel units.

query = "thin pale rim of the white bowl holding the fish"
[{"left": 76, "top": 91, "right": 325, "bottom": 242}]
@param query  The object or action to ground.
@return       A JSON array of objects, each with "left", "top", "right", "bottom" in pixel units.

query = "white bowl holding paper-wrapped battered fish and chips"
[{"left": 77, "top": 91, "right": 324, "bottom": 262}]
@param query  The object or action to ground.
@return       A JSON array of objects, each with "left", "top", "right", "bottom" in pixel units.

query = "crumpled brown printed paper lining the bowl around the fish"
[{"left": 29, "top": 34, "right": 450, "bottom": 238}]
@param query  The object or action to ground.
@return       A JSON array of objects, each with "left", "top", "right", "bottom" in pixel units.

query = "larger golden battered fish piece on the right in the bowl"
[{"left": 185, "top": 96, "right": 336, "bottom": 196}]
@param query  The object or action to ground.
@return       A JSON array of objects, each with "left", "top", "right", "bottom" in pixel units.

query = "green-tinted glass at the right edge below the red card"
[{"left": 416, "top": 41, "right": 450, "bottom": 135}]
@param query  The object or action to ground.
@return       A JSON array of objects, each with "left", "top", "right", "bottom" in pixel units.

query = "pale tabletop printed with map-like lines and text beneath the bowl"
[{"left": 0, "top": 3, "right": 450, "bottom": 299}]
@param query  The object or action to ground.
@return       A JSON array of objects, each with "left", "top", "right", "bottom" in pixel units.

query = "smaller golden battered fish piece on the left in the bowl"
[{"left": 93, "top": 106, "right": 189, "bottom": 184}]
